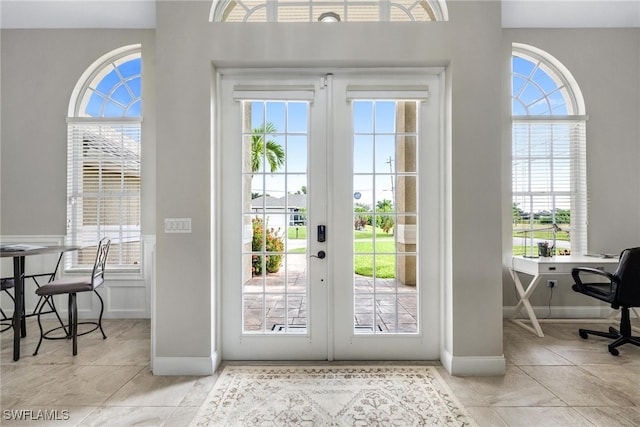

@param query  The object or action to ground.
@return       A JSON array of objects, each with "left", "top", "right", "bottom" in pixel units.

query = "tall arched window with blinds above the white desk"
[{"left": 511, "top": 44, "right": 587, "bottom": 256}]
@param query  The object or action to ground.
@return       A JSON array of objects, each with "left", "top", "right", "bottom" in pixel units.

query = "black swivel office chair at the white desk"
[{"left": 571, "top": 248, "right": 640, "bottom": 356}]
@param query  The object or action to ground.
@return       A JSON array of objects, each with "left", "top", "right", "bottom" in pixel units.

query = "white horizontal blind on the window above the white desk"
[{"left": 512, "top": 117, "right": 588, "bottom": 256}]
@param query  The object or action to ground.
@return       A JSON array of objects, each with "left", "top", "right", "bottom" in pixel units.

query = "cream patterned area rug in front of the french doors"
[{"left": 191, "top": 366, "right": 476, "bottom": 427}]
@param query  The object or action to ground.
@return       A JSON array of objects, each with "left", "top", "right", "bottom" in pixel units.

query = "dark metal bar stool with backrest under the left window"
[{"left": 33, "top": 237, "right": 111, "bottom": 356}]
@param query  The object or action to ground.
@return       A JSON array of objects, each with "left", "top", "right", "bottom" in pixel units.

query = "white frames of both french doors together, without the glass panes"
[{"left": 214, "top": 68, "right": 445, "bottom": 360}]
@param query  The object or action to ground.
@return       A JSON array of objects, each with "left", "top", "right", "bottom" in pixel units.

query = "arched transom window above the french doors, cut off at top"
[{"left": 209, "top": 0, "right": 448, "bottom": 22}]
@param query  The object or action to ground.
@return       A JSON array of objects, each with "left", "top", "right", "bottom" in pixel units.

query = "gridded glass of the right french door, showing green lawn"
[{"left": 352, "top": 100, "right": 420, "bottom": 334}]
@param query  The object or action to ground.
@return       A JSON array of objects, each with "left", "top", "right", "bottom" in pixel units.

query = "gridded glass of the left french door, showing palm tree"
[{"left": 242, "top": 101, "right": 309, "bottom": 334}]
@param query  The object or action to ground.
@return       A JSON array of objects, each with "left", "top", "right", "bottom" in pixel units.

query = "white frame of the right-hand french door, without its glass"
[{"left": 329, "top": 69, "right": 444, "bottom": 360}]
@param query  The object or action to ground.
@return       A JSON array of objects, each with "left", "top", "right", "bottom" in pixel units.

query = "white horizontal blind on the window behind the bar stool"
[{"left": 66, "top": 118, "right": 141, "bottom": 269}]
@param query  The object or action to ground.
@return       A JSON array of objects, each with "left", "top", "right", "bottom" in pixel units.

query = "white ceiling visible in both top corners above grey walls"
[{"left": 0, "top": 0, "right": 640, "bottom": 28}]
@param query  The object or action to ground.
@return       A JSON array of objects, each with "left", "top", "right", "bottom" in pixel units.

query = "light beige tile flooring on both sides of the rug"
[{"left": 0, "top": 320, "right": 640, "bottom": 427}]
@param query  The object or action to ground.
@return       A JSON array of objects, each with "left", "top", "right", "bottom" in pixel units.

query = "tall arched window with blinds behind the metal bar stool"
[{"left": 66, "top": 45, "right": 142, "bottom": 270}]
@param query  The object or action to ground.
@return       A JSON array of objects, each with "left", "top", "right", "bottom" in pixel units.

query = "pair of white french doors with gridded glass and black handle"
[{"left": 215, "top": 70, "right": 442, "bottom": 360}]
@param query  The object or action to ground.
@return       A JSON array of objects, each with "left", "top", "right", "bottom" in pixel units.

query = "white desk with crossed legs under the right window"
[{"left": 510, "top": 255, "right": 618, "bottom": 337}]
